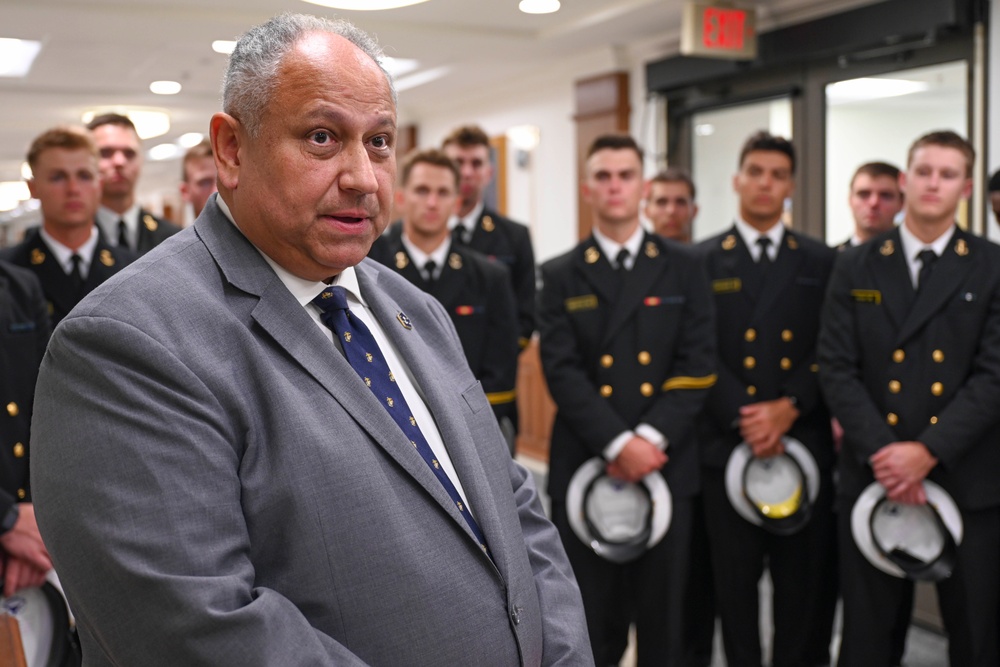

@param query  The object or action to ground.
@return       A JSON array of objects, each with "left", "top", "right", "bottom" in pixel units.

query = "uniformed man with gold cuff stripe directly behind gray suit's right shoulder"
[{"left": 369, "top": 150, "right": 519, "bottom": 446}]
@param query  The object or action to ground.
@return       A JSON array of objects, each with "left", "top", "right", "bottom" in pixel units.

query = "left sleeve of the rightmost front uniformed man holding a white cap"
[{"left": 818, "top": 253, "right": 896, "bottom": 465}]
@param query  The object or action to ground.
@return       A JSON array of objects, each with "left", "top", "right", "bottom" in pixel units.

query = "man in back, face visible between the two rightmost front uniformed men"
[{"left": 837, "top": 162, "right": 903, "bottom": 250}]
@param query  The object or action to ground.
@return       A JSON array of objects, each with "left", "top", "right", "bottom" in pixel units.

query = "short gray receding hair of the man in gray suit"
[{"left": 222, "top": 13, "right": 396, "bottom": 138}]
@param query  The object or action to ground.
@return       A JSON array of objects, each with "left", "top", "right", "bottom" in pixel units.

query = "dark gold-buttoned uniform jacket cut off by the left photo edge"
[{"left": 0, "top": 262, "right": 50, "bottom": 516}]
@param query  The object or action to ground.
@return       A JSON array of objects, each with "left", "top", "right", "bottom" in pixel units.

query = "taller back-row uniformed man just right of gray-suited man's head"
[{"left": 441, "top": 125, "right": 535, "bottom": 348}]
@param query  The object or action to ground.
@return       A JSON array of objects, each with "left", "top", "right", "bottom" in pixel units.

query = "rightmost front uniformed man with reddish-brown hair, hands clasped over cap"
[{"left": 819, "top": 131, "right": 1000, "bottom": 667}]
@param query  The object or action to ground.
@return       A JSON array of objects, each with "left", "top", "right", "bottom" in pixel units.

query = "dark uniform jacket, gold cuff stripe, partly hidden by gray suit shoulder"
[{"left": 369, "top": 221, "right": 519, "bottom": 428}]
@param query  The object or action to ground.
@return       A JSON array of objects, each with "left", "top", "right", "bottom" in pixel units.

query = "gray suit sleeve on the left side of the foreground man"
[{"left": 32, "top": 317, "right": 372, "bottom": 666}]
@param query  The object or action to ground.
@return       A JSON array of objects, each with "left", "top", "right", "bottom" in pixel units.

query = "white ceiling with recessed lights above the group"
[{"left": 0, "top": 0, "right": 872, "bottom": 206}]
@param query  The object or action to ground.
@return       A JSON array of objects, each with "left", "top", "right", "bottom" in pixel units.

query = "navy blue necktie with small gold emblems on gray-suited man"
[{"left": 312, "top": 287, "right": 489, "bottom": 554}]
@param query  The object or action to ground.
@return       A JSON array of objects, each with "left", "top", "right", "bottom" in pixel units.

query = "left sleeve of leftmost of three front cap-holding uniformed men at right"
[{"left": 538, "top": 264, "right": 632, "bottom": 456}]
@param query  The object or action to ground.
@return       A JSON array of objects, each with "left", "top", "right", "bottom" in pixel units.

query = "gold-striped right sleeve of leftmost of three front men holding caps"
[{"left": 640, "top": 262, "right": 717, "bottom": 443}]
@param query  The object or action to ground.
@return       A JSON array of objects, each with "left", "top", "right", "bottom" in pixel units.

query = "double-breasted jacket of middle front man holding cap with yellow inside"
[{"left": 698, "top": 226, "right": 836, "bottom": 469}]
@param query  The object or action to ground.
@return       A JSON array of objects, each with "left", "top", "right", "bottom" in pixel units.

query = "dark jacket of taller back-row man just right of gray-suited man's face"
[{"left": 456, "top": 208, "right": 535, "bottom": 348}]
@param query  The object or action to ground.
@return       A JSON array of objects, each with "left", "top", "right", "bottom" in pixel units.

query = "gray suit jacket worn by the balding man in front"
[{"left": 32, "top": 200, "right": 592, "bottom": 666}]
